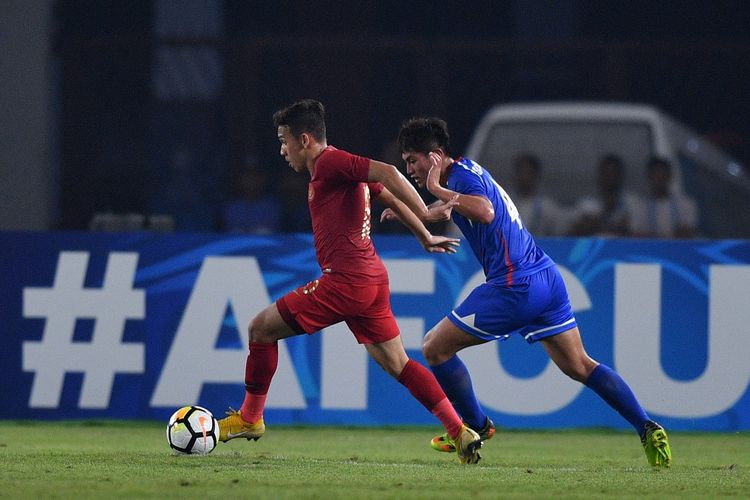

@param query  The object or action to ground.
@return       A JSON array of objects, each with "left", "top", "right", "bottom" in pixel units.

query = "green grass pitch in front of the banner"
[{"left": 0, "top": 421, "right": 750, "bottom": 499}]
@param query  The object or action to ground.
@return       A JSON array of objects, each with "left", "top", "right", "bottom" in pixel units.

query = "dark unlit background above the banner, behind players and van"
[{"left": 52, "top": 0, "right": 750, "bottom": 231}]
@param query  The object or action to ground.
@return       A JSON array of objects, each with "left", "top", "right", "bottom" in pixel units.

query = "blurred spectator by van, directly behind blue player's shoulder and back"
[{"left": 511, "top": 153, "right": 567, "bottom": 236}]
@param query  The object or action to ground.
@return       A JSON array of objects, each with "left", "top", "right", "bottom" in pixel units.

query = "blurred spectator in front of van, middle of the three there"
[{"left": 569, "top": 154, "right": 639, "bottom": 236}]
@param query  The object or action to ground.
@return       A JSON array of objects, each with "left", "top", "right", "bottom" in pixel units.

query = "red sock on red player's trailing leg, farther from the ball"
[{"left": 398, "top": 359, "right": 463, "bottom": 438}]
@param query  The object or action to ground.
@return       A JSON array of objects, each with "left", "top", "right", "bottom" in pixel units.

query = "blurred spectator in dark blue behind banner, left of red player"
[{"left": 222, "top": 155, "right": 282, "bottom": 234}]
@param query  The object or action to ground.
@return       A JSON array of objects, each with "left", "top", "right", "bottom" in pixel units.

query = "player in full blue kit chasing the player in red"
[{"left": 381, "top": 118, "right": 672, "bottom": 467}]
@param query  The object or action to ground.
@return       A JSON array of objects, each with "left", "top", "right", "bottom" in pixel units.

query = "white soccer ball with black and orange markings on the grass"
[{"left": 167, "top": 406, "right": 219, "bottom": 455}]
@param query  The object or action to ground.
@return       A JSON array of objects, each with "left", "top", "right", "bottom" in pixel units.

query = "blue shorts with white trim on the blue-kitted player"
[{"left": 448, "top": 266, "right": 576, "bottom": 344}]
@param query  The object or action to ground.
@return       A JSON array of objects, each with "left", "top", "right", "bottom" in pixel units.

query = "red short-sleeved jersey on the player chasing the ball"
[{"left": 307, "top": 146, "right": 388, "bottom": 284}]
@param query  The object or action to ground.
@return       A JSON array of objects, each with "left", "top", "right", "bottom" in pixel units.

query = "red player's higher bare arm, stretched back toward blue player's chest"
[{"left": 368, "top": 160, "right": 458, "bottom": 222}]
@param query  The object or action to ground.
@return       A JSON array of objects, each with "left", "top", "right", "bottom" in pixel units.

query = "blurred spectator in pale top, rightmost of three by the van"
[{"left": 632, "top": 158, "right": 698, "bottom": 238}]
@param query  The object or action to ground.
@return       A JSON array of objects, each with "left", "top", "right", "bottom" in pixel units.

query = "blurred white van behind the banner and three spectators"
[{"left": 466, "top": 102, "right": 750, "bottom": 238}]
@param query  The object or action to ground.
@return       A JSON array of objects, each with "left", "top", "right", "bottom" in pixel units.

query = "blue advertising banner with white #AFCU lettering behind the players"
[{"left": 0, "top": 232, "right": 750, "bottom": 431}]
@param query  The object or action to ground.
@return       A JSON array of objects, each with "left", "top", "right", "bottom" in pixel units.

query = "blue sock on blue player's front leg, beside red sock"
[{"left": 430, "top": 355, "right": 488, "bottom": 431}]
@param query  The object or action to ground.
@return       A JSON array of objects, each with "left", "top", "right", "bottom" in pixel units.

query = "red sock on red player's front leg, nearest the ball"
[{"left": 240, "top": 342, "right": 279, "bottom": 423}]
